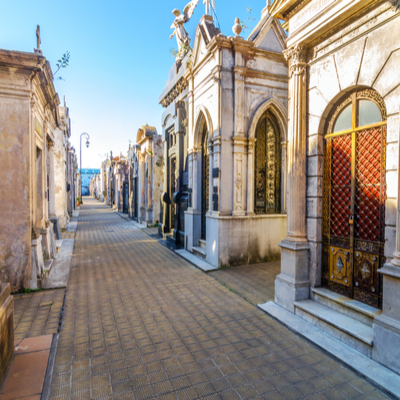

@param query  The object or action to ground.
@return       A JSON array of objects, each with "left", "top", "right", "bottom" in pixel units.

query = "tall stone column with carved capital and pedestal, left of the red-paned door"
[{"left": 275, "top": 45, "right": 310, "bottom": 313}]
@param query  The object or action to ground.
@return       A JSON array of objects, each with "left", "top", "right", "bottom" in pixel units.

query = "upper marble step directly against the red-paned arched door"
[{"left": 311, "top": 288, "right": 382, "bottom": 327}]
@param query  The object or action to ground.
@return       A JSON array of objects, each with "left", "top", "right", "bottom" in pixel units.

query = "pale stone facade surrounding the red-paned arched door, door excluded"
[{"left": 271, "top": 0, "right": 400, "bottom": 373}]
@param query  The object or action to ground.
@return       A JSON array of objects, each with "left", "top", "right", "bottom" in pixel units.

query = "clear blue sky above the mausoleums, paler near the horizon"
[{"left": 0, "top": 0, "right": 266, "bottom": 168}]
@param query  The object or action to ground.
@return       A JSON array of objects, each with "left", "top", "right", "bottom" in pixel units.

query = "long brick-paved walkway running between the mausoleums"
[{"left": 51, "top": 200, "right": 385, "bottom": 400}]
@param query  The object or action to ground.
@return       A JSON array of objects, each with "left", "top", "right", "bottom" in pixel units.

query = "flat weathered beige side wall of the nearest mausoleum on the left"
[{"left": 0, "top": 90, "right": 31, "bottom": 290}]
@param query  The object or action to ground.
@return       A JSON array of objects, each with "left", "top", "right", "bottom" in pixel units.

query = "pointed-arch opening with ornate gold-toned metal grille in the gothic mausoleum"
[{"left": 254, "top": 111, "right": 282, "bottom": 214}]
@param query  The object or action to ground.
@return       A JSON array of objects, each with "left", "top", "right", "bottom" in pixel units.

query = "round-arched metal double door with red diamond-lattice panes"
[{"left": 322, "top": 89, "right": 386, "bottom": 307}]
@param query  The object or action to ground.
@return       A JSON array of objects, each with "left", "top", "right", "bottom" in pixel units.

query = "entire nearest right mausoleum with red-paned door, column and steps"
[{"left": 262, "top": 0, "right": 400, "bottom": 382}]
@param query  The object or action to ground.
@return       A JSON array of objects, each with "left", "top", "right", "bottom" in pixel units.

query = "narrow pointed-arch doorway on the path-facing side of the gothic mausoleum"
[{"left": 201, "top": 122, "right": 210, "bottom": 240}]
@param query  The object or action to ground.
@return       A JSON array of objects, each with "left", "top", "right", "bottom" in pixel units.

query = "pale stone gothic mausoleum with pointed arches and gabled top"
[{"left": 184, "top": 7, "right": 288, "bottom": 267}]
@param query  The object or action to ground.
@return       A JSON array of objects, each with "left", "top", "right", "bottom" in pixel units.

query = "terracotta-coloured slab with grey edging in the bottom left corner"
[{"left": 0, "top": 334, "right": 58, "bottom": 400}]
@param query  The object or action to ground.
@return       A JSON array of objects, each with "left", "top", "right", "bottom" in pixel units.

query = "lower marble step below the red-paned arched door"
[{"left": 294, "top": 300, "right": 373, "bottom": 357}]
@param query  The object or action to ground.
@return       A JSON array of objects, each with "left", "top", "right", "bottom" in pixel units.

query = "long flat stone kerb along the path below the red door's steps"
[{"left": 257, "top": 301, "right": 400, "bottom": 399}]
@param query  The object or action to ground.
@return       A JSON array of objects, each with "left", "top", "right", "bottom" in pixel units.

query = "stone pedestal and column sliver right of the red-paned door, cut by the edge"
[{"left": 372, "top": 124, "right": 400, "bottom": 374}]
